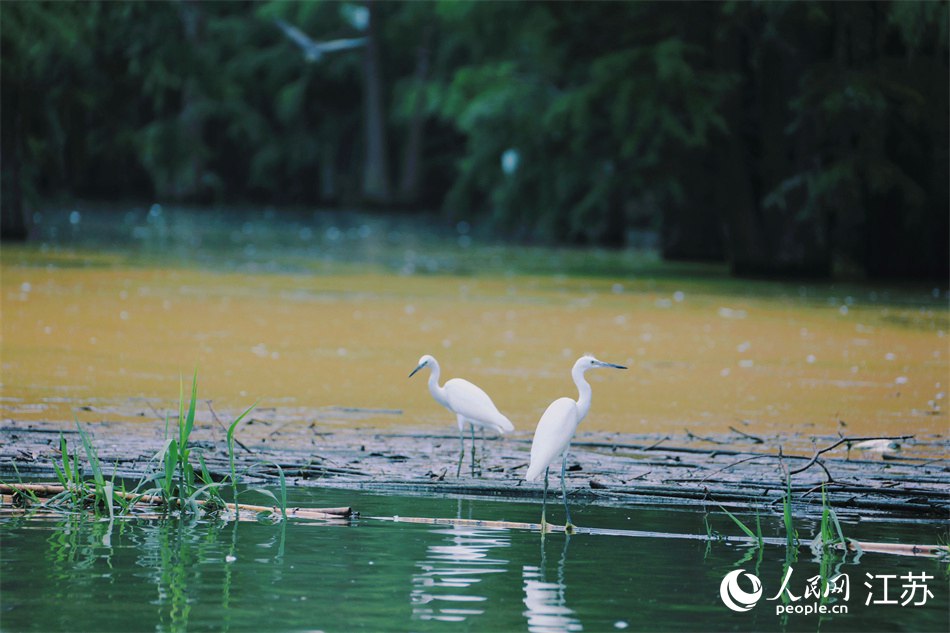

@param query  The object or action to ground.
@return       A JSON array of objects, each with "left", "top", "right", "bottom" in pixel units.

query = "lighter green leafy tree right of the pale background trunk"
[{"left": 430, "top": 3, "right": 734, "bottom": 245}]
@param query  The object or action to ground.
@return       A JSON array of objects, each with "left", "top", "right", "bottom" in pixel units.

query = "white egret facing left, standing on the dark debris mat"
[{"left": 409, "top": 354, "right": 515, "bottom": 477}]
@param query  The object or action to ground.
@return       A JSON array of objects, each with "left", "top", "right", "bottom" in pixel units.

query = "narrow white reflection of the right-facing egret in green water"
[{"left": 521, "top": 536, "right": 584, "bottom": 633}]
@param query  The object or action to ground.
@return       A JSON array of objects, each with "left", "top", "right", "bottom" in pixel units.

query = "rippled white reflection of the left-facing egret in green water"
[{"left": 410, "top": 526, "right": 511, "bottom": 622}]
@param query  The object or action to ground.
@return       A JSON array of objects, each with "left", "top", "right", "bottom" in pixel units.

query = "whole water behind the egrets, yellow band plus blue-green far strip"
[{"left": 0, "top": 205, "right": 950, "bottom": 436}]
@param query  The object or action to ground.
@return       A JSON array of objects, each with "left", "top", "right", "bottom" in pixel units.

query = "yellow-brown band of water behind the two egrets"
[{"left": 0, "top": 241, "right": 950, "bottom": 435}]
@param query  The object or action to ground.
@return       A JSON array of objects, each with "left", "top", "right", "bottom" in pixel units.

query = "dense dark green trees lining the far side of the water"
[{"left": 0, "top": 0, "right": 950, "bottom": 277}]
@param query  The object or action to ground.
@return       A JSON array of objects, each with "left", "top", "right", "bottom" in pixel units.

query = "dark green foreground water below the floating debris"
[{"left": 0, "top": 489, "right": 948, "bottom": 631}]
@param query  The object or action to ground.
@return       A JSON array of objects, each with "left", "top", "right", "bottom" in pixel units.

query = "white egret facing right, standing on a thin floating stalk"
[{"left": 525, "top": 354, "right": 626, "bottom": 534}]
